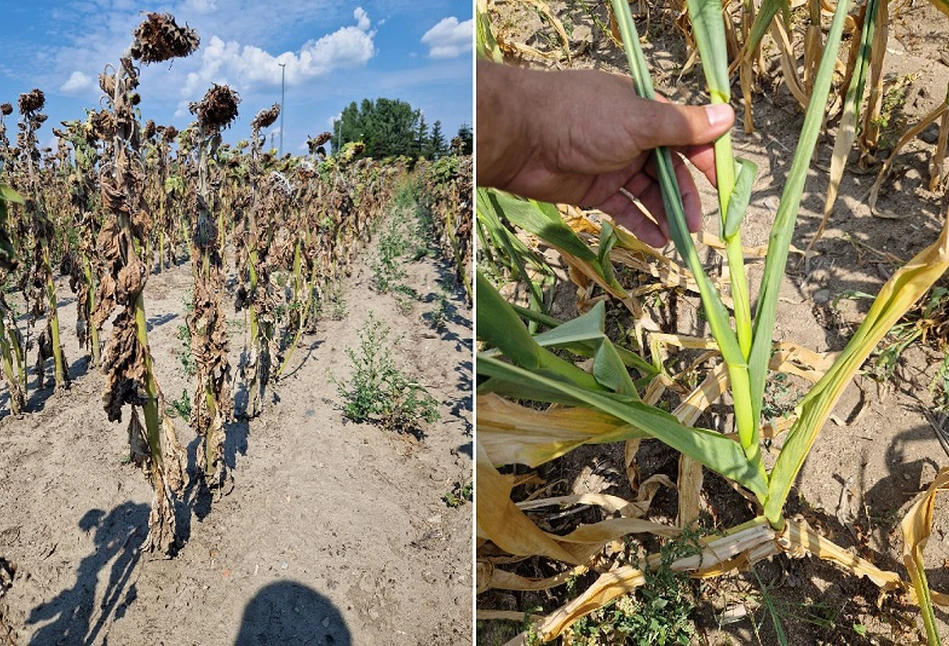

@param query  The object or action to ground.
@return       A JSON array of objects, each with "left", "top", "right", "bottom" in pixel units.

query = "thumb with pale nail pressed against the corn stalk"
[{"left": 631, "top": 101, "right": 735, "bottom": 149}]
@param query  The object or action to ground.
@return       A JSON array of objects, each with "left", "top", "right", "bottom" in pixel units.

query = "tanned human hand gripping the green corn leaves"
[{"left": 476, "top": 61, "right": 735, "bottom": 247}]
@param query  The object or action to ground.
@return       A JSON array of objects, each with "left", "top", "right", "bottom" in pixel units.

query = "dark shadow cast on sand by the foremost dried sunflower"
[{"left": 26, "top": 502, "right": 149, "bottom": 646}]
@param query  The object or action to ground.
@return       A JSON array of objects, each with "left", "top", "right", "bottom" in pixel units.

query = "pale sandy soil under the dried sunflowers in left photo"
[{"left": 0, "top": 201, "right": 472, "bottom": 646}]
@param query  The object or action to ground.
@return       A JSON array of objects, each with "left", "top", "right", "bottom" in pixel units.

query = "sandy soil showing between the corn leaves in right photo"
[{"left": 479, "top": 3, "right": 949, "bottom": 644}]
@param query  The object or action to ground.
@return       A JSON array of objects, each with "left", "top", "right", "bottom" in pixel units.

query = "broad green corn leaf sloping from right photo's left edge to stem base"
[{"left": 478, "top": 354, "right": 767, "bottom": 496}]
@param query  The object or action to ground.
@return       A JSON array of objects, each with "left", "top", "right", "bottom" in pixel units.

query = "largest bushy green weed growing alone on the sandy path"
[{"left": 333, "top": 312, "right": 441, "bottom": 435}]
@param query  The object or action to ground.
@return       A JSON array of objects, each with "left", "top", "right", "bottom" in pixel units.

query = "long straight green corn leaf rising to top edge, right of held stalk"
[{"left": 748, "top": 0, "right": 849, "bottom": 438}]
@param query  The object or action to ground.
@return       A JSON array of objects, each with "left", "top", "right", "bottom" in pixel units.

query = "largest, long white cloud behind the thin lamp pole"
[{"left": 176, "top": 7, "right": 376, "bottom": 115}]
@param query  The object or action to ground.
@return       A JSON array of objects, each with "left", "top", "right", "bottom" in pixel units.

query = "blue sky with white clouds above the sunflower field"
[{"left": 0, "top": 0, "right": 473, "bottom": 154}]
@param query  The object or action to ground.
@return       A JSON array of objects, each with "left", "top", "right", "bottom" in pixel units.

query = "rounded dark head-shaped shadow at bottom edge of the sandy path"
[{"left": 234, "top": 581, "right": 352, "bottom": 646}]
